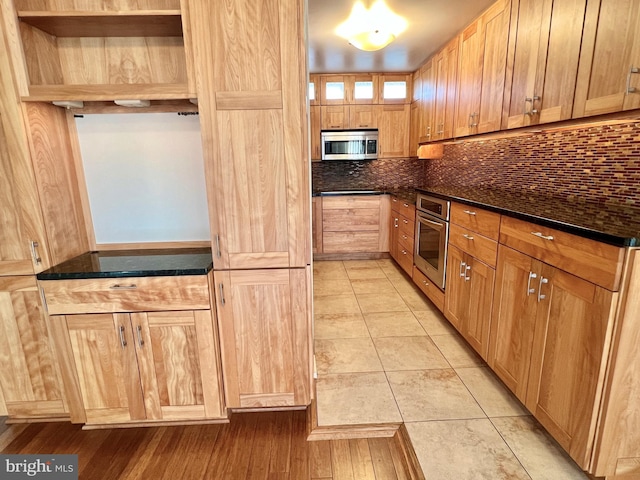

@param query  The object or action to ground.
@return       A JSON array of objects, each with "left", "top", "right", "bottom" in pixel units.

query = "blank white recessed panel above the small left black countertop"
[{"left": 76, "top": 113, "right": 210, "bottom": 244}]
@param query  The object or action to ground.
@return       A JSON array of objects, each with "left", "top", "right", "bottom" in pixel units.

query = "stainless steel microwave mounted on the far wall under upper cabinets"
[{"left": 320, "top": 130, "right": 378, "bottom": 160}]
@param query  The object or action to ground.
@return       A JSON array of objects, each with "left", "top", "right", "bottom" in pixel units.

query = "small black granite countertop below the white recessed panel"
[{"left": 37, "top": 248, "right": 213, "bottom": 280}]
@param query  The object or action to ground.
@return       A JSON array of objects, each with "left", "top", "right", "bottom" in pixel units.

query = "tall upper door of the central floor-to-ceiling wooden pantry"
[{"left": 188, "top": 0, "right": 311, "bottom": 269}]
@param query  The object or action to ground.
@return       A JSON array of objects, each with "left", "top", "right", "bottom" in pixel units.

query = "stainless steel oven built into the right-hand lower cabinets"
[{"left": 414, "top": 193, "right": 451, "bottom": 290}]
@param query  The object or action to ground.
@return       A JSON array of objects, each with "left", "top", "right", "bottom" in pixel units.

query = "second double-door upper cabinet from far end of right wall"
[{"left": 454, "top": 0, "right": 511, "bottom": 137}]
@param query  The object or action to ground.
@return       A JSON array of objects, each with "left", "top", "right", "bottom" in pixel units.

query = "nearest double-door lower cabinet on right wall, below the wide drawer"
[{"left": 488, "top": 245, "right": 617, "bottom": 470}]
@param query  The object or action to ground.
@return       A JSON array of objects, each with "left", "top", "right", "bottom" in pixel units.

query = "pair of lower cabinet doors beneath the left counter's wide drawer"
[{"left": 59, "top": 310, "right": 224, "bottom": 425}]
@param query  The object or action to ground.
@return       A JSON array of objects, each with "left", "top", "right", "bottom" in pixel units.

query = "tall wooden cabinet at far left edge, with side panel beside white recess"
[{"left": 0, "top": 1, "right": 88, "bottom": 418}]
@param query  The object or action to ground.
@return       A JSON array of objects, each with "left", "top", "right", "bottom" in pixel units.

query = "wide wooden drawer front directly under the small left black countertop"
[{"left": 40, "top": 275, "right": 211, "bottom": 315}]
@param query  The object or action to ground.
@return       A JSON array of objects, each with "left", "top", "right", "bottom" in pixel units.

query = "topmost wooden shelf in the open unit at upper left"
[{"left": 18, "top": 10, "right": 182, "bottom": 37}]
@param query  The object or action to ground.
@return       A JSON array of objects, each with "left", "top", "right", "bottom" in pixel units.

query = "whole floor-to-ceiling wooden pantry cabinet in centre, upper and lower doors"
[{"left": 189, "top": 0, "right": 311, "bottom": 408}]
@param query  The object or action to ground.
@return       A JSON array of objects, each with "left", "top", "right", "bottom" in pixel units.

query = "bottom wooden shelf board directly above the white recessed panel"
[{"left": 22, "top": 83, "right": 196, "bottom": 102}]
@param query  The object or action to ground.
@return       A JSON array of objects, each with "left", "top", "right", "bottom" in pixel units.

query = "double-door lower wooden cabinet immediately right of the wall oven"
[{"left": 443, "top": 244, "right": 495, "bottom": 360}]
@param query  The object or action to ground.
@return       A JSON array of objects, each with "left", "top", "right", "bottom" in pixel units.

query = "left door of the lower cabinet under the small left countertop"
[{"left": 66, "top": 313, "right": 146, "bottom": 424}]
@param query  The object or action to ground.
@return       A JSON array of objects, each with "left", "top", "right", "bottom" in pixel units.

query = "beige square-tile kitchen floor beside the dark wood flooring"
[{"left": 314, "top": 260, "right": 587, "bottom": 480}]
